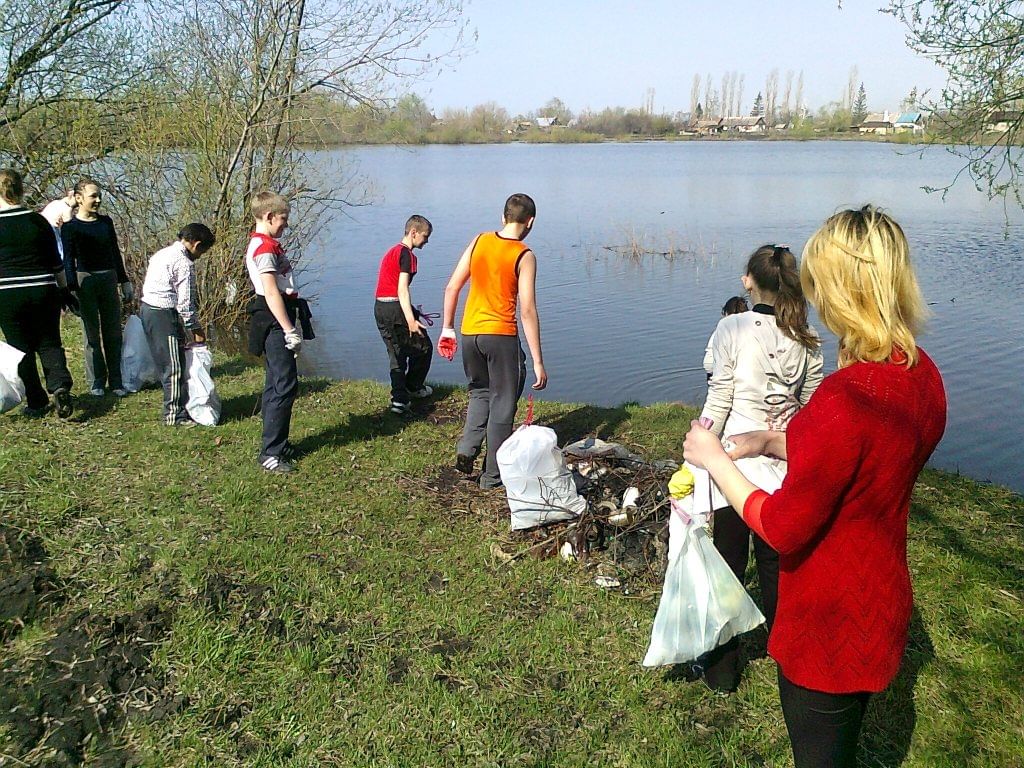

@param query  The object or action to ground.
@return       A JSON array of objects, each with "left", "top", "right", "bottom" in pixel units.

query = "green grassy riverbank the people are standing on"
[{"left": 0, "top": 350, "right": 1024, "bottom": 768}]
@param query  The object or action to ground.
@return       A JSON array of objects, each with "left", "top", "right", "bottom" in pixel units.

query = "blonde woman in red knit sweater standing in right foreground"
[{"left": 684, "top": 206, "right": 946, "bottom": 768}]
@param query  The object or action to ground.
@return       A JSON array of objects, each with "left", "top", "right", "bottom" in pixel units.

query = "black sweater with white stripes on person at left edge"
[{"left": 0, "top": 206, "right": 63, "bottom": 290}]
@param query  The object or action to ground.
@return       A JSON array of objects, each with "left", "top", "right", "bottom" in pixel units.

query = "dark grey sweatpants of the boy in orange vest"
[{"left": 457, "top": 334, "right": 526, "bottom": 488}]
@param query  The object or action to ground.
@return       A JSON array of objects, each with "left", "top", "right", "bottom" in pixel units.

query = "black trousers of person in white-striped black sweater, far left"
[{"left": 0, "top": 285, "right": 72, "bottom": 409}]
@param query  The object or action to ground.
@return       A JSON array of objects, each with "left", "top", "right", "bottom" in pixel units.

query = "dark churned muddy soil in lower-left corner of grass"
[{"left": 0, "top": 527, "right": 178, "bottom": 768}]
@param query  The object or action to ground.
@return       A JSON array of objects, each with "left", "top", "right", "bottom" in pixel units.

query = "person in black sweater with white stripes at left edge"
[{"left": 0, "top": 169, "right": 72, "bottom": 419}]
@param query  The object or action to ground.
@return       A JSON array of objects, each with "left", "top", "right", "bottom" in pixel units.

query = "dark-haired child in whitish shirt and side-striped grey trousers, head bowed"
[{"left": 140, "top": 223, "right": 214, "bottom": 427}]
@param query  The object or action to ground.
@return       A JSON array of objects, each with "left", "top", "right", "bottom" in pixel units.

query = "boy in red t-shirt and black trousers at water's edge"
[{"left": 374, "top": 216, "right": 434, "bottom": 414}]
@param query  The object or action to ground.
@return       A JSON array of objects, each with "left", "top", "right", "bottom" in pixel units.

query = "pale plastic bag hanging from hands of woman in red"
[{"left": 643, "top": 495, "right": 765, "bottom": 667}]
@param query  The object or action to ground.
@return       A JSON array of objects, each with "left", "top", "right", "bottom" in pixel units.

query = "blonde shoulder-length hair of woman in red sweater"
[{"left": 800, "top": 205, "right": 928, "bottom": 368}]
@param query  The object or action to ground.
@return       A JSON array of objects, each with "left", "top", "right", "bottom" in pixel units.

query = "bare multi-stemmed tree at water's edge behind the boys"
[{"left": 111, "top": 0, "right": 471, "bottom": 323}]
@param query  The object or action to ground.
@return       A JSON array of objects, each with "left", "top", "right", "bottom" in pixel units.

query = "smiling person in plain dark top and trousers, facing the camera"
[{"left": 60, "top": 178, "right": 134, "bottom": 397}]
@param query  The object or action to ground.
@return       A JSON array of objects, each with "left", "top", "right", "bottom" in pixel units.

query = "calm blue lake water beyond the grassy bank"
[{"left": 303, "top": 141, "right": 1024, "bottom": 492}]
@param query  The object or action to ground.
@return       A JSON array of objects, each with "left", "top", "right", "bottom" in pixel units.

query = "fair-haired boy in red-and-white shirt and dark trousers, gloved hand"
[{"left": 246, "top": 191, "right": 302, "bottom": 474}]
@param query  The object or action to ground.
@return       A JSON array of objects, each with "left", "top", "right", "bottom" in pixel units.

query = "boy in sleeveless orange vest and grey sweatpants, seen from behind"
[{"left": 437, "top": 195, "right": 548, "bottom": 488}]
